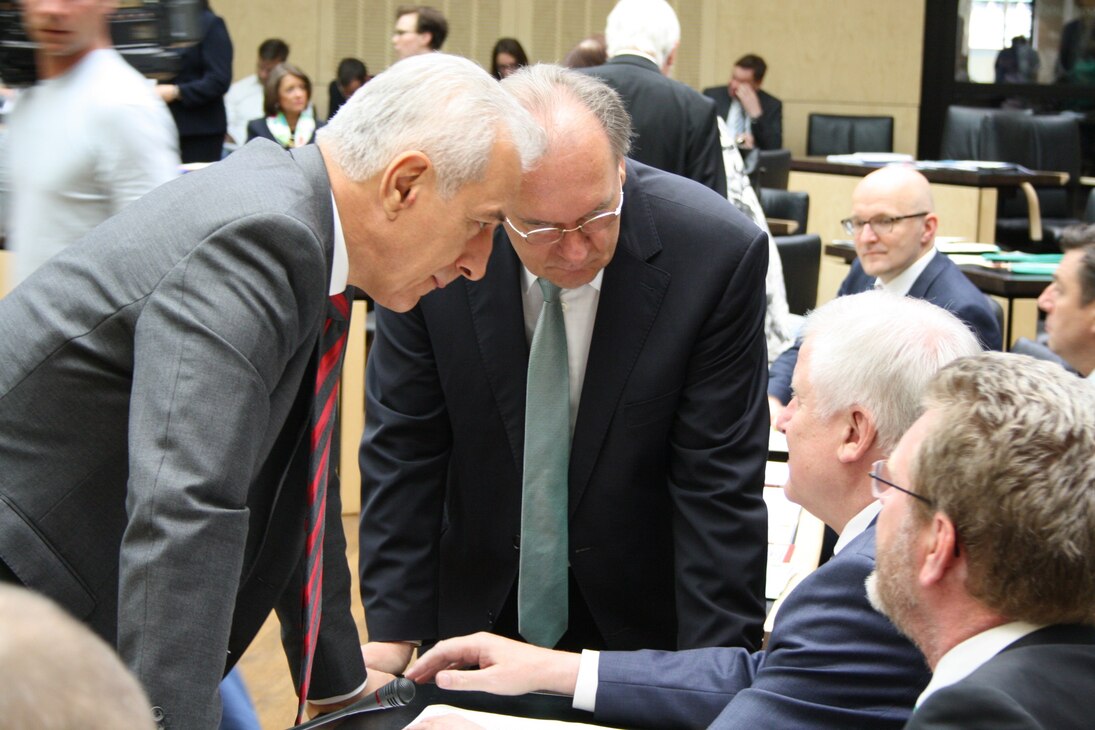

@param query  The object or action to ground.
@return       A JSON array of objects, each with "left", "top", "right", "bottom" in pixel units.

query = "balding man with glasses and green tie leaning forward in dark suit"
[{"left": 361, "top": 66, "right": 768, "bottom": 671}]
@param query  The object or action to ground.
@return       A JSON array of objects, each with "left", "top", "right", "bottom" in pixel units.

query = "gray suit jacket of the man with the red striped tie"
[{"left": 0, "top": 141, "right": 365, "bottom": 728}]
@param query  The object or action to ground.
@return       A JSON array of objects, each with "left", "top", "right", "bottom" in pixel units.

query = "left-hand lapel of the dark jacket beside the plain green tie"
[{"left": 465, "top": 239, "right": 529, "bottom": 474}]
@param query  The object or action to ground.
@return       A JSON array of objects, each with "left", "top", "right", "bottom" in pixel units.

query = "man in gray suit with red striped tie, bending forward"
[{"left": 0, "top": 54, "right": 543, "bottom": 728}]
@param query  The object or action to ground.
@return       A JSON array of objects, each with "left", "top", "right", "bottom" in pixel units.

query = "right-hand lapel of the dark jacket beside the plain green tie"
[{"left": 569, "top": 169, "right": 669, "bottom": 514}]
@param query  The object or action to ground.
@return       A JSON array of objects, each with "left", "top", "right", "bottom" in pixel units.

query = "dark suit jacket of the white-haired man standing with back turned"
[{"left": 578, "top": 55, "right": 726, "bottom": 197}]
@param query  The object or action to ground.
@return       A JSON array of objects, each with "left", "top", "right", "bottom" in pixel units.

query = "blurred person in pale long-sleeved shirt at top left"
[{"left": 0, "top": 0, "right": 178, "bottom": 285}]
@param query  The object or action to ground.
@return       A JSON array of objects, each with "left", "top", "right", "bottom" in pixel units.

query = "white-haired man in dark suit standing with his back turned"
[{"left": 581, "top": 0, "right": 726, "bottom": 197}]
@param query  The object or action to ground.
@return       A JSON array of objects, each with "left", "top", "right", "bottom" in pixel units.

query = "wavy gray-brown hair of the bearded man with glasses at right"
[{"left": 910, "top": 352, "right": 1095, "bottom": 624}]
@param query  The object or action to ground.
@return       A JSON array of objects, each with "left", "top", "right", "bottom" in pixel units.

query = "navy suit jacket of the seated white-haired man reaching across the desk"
[{"left": 596, "top": 523, "right": 931, "bottom": 730}]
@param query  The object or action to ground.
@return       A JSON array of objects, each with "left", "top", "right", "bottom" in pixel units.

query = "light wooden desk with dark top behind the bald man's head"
[{"left": 787, "top": 158, "right": 1065, "bottom": 304}]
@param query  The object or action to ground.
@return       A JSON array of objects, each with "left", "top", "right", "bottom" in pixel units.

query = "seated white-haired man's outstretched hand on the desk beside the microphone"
[{"left": 406, "top": 633, "right": 581, "bottom": 696}]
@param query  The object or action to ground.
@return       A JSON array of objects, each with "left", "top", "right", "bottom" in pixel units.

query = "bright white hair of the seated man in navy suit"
[{"left": 803, "top": 291, "right": 981, "bottom": 453}]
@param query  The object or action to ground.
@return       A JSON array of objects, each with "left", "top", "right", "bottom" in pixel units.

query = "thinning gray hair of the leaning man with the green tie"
[{"left": 502, "top": 63, "right": 632, "bottom": 160}]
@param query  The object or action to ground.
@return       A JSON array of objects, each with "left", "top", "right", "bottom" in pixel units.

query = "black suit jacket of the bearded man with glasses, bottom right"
[{"left": 904, "top": 625, "right": 1095, "bottom": 730}]
